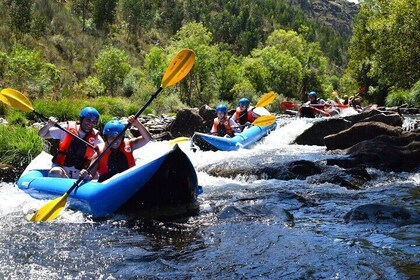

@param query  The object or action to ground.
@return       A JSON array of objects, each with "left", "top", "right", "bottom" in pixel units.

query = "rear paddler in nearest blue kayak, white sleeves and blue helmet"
[{"left": 38, "top": 107, "right": 104, "bottom": 178}]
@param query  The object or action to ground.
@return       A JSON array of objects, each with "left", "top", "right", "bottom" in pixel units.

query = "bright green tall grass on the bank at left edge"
[{"left": 0, "top": 125, "right": 43, "bottom": 171}]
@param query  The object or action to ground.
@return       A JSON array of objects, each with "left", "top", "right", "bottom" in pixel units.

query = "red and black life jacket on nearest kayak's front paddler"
[{"left": 98, "top": 139, "right": 136, "bottom": 178}]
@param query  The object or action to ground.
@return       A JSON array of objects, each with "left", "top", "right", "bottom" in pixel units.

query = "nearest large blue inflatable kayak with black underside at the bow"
[{"left": 16, "top": 145, "right": 201, "bottom": 218}]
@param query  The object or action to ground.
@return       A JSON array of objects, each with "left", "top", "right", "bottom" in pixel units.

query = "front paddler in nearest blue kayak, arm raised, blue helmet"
[{"left": 80, "top": 116, "right": 152, "bottom": 182}]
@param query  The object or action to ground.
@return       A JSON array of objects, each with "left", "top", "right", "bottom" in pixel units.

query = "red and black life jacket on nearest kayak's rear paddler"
[{"left": 52, "top": 122, "right": 99, "bottom": 170}]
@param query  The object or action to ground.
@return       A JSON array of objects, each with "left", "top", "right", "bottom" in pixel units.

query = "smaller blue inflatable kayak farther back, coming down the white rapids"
[{"left": 191, "top": 122, "right": 277, "bottom": 151}]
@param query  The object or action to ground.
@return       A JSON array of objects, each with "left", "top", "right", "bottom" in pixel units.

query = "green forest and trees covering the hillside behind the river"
[{"left": 0, "top": 0, "right": 420, "bottom": 116}]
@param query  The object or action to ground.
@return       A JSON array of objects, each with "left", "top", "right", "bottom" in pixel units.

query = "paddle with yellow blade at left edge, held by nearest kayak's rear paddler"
[{"left": 0, "top": 88, "right": 95, "bottom": 149}]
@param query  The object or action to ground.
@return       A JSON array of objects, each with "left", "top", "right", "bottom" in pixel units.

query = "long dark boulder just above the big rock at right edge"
[{"left": 324, "top": 122, "right": 402, "bottom": 150}]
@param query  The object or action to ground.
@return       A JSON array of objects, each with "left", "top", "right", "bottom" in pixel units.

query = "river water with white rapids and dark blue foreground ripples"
[{"left": 0, "top": 115, "right": 420, "bottom": 279}]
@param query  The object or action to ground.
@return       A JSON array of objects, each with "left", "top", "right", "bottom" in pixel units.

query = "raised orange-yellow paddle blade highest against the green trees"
[{"left": 161, "top": 49, "right": 195, "bottom": 88}]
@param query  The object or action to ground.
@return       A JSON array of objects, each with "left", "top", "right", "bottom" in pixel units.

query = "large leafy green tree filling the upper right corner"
[{"left": 348, "top": 0, "right": 420, "bottom": 104}]
